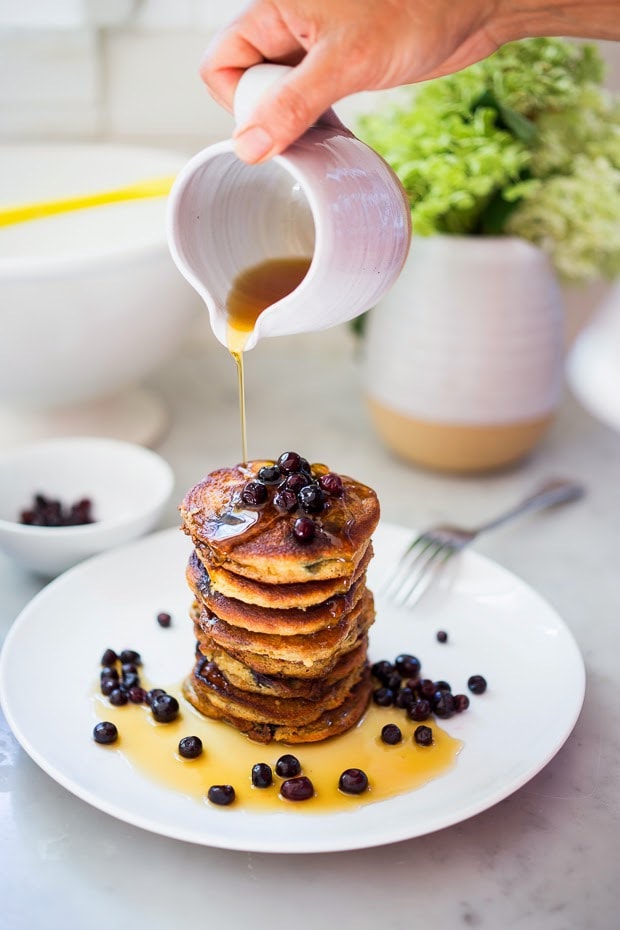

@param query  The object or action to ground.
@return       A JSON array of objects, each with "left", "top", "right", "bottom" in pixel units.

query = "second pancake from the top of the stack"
[{"left": 196, "top": 543, "right": 373, "bottom": 610}]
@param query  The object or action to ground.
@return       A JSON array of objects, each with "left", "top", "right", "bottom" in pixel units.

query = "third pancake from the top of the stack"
[{"left": 185, "top": 551, "right": 366, "bottom": 636}]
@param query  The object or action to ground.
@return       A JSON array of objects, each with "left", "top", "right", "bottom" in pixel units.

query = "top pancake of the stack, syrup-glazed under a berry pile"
[{"left": 180, "top": 461, "right": 379, "bottom": 584}]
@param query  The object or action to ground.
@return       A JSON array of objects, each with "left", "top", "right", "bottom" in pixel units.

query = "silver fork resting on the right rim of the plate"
[{"left": 379, "top": 479, "right": 585, "bottom": 607}]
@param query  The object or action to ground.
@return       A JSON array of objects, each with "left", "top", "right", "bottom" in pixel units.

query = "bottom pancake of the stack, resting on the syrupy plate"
[{"left": 183, "top": 669, "right": 372, "bottom": 743}]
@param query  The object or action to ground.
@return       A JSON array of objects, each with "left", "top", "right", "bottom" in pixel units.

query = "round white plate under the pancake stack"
[{"left": 0, "top": 524, "right": 585, "bottom": 853}]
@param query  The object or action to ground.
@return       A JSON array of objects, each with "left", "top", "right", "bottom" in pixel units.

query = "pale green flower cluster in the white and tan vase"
[{"left": 358, "top": 38, "right": 620, "bottom": 282}]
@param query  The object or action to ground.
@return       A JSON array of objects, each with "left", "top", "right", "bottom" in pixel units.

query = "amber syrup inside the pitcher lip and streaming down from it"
[{"left": 226, "top": 256, "right": 311, "bottom": 462}]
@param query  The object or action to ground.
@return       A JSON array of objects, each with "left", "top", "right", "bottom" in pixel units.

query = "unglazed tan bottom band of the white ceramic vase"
[{"left": 368, "top": 398, "right": 553, "bottom": 472}]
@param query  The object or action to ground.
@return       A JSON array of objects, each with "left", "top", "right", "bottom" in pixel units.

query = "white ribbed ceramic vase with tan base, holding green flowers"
[{"left": 365, "top": 236, "right": 564, "bottom": 472}]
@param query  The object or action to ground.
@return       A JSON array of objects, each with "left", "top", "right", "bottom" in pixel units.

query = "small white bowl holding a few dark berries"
[{"left": 0, "top": 437, "right": 174, "bottom": 577}]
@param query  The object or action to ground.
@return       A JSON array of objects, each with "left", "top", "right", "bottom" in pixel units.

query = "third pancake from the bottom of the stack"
[{"left": 196, "top": 637, "right": 368, "bottom": 701}]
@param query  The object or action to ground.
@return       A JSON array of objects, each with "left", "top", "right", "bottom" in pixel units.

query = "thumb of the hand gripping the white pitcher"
[{"left": 233, "top": 43, "right": 361, "bottom": 164}]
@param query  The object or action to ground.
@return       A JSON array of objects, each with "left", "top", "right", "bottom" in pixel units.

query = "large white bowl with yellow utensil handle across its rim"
[{"left": 0, "top": 144, "right": 200, "bottom": 446}]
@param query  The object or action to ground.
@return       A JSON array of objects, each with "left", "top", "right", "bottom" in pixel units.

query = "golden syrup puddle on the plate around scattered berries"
[{"left": 94, "top": 688, "right": 462, "bottom": 814}]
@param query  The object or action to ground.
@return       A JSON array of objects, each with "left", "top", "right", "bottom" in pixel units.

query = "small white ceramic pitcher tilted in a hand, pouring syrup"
[{"left": 168, "top": 64, "right": 411, "bottom": 350}]
